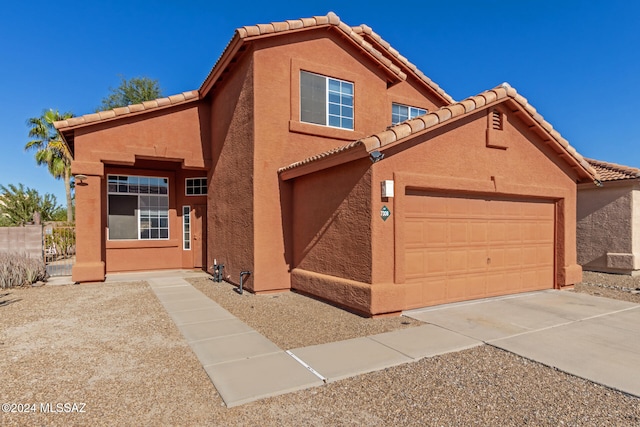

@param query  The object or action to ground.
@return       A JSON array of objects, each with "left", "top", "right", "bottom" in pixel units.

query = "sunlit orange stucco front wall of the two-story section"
[{"left": 252, "top": 31, "right": 442, "bottom": 291}]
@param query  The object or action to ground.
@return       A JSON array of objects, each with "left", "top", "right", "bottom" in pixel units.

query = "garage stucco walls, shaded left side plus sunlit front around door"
[{"left": 292, "top": 105, "right": 581, "bottom": 315}]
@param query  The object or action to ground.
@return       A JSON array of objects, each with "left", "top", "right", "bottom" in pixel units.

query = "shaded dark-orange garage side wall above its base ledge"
[{"left": 280, "top": 158, "right": 371, "bottom": 279}]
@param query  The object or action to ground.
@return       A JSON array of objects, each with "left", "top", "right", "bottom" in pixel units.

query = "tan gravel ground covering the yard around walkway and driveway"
[{"left": 0, "top": 274, "right": 640, "bottom": 426}]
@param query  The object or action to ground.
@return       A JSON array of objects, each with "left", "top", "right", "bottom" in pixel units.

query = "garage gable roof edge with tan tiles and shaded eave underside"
[{"left": 278, "top": 83, "right": 600, "bottom": 183}]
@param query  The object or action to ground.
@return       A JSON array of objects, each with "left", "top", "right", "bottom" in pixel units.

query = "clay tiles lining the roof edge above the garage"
[{"left": 278, "top": 83, "right": 600, "bottom": 181}]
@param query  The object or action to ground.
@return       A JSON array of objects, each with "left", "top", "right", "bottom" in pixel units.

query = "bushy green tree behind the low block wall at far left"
[{"left": 0, "top": 184, "right": 61, "bottom": 226}]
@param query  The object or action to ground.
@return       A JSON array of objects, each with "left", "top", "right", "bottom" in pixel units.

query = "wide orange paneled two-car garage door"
[{"left": 401, "top": 190, "right": 555, "bottom": 308}]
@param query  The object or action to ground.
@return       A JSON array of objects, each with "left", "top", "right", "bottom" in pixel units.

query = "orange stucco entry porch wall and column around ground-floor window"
[{"left": 72, "top": 103, "right": 211, "bottom": 282}]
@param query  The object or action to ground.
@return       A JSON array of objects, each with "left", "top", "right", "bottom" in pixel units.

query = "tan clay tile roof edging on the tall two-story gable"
[{"left": 200, "top": 12, "right": 454, "bottom": 103}]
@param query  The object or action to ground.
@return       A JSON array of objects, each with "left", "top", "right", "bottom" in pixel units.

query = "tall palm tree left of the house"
[{"left": 24, "top": 109, "right": 73, "bottom": 222}]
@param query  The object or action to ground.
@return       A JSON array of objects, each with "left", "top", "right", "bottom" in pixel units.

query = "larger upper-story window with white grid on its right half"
[{"left": 300, "top": 71, "right": 353, "bottom": 130}]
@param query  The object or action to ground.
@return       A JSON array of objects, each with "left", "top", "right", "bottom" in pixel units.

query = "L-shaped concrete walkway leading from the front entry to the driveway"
[{"left": 141, "top": 272, "right": 481, "bottom": 407}]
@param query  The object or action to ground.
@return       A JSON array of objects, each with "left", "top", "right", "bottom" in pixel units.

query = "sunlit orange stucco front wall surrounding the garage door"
[{"left": 372, "top": 110, "right": 581, "bottom": 286}]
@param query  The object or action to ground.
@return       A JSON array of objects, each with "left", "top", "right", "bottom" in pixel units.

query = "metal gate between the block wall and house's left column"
[{"left": 42, "top": 223, "right": 76, "bottom": 276}]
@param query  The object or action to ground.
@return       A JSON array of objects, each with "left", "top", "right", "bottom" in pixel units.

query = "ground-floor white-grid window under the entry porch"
[{"left": 107, "top": 175, "right": 169, "bottom": 240}]
